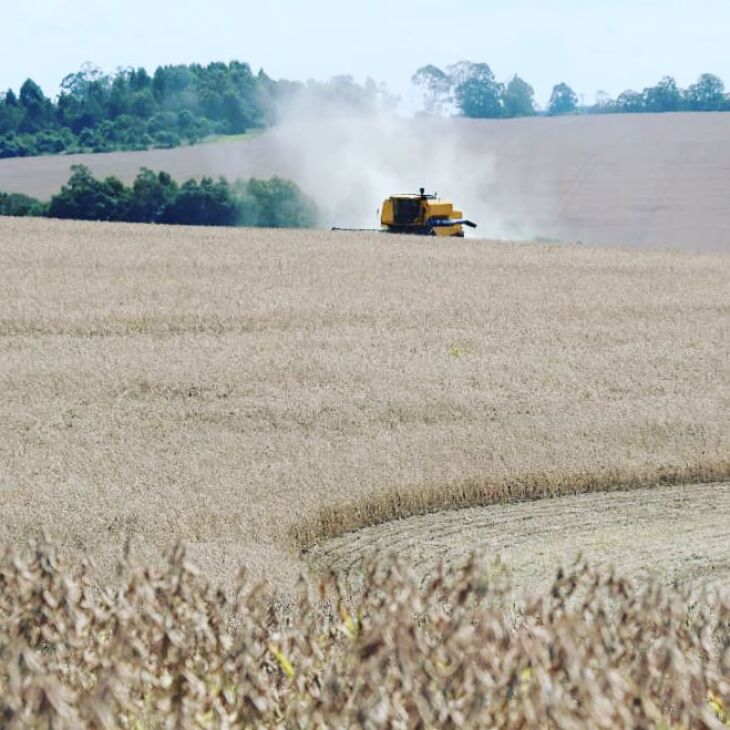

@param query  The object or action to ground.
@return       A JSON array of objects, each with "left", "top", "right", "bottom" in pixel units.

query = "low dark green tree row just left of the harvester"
[{"left": 0, "top": 165, "right": 318, "bottom": 228}]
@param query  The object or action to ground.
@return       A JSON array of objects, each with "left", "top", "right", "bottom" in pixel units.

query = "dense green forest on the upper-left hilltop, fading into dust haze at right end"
[{"left": 0, "top": 61, "right": 387, "bottom": 158}]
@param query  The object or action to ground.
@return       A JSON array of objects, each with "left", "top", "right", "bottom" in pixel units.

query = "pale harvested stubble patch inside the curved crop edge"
[{"left": 309, "top": 482, "right": 730, "bottom": 589}]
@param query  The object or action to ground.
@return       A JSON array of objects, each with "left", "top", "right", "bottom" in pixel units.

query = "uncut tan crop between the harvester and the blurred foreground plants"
[{"left": 0, "top": 219, "right": 730, "bottom": 589}]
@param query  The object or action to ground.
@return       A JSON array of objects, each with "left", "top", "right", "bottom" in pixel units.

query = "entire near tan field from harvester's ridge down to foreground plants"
[{"left": 0, "top": 219, "right": 730, "bottom": 728}]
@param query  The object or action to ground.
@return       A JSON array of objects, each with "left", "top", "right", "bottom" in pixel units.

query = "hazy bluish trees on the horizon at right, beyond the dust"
[{"left": 411, "top": 61, "right": 730, "bottom": 119}]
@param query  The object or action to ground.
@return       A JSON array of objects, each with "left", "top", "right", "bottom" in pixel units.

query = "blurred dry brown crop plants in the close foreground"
[{"left": 0, "top": 544, "right": 730, "bottom": 728}]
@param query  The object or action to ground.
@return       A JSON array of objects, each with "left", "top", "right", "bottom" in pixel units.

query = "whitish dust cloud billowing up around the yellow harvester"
[{"left": 258, "top": 107, "right": 533, "bottom": 238}]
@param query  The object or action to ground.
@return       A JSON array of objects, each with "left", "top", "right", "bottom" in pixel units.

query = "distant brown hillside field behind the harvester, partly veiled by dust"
[{"left": 0, "top": 114, "right": 730, "bottom": 251}]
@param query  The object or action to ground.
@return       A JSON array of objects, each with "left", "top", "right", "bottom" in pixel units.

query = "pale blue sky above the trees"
[{"left": 0, "top": 0, "right": 730, "bottom": 110}]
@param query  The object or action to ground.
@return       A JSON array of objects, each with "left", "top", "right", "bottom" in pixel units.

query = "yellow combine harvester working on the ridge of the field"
[{"left": 332, "top": 188, "right": 477, "bottom": 238}]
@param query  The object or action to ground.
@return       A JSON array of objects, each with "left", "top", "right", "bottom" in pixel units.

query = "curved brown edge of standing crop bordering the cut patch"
[{"left": 291, "top": 459, "right": 730, "bottom": 553}]
